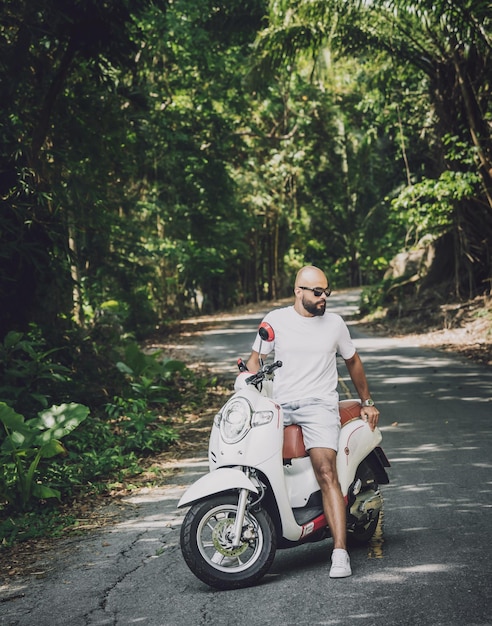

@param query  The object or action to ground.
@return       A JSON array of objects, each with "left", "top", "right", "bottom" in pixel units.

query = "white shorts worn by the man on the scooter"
[{"left": 282, "top": 398, "right": 340, "bottom": 452}]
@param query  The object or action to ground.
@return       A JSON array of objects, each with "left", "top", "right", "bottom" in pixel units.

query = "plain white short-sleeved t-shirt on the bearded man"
[{"left": 253, "top": 306, "right": 355, "bottom": 404}]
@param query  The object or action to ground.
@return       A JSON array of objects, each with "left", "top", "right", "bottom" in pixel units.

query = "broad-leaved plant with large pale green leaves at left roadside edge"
[{"left": 0, "top": 402, "right": 89, "bottom": 510}]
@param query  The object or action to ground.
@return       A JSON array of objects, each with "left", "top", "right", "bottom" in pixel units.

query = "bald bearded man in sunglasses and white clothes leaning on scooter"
[{"left": 246, "top": 266, "right": 379, "bottom": 578}]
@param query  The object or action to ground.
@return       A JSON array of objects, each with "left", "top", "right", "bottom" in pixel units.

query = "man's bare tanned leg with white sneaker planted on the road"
[{"left": 309, "top": 448, "right": 352, "bottom": 578}]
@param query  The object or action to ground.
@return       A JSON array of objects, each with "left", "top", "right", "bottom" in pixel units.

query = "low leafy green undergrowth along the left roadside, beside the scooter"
[{"left": 0, "top": 326, "right": 202, "bottom": 545}]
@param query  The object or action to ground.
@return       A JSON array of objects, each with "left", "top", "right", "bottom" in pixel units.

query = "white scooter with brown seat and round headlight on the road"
[{"left": 178, "top": 323, "right": 389, "bottom": 589}]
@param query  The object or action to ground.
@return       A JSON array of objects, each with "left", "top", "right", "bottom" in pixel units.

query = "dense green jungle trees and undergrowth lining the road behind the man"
[{"left": 0, "top": 0, "right": 492, "bottom": 528}]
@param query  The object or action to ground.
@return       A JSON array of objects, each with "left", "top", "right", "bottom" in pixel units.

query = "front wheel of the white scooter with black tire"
[{"left": 181, "top": 494, "right": 277, "bottom": 589}]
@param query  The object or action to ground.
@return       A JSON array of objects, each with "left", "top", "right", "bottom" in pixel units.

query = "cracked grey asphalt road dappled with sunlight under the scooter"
[{"left": 0, "top": 292, "right": 492, "bottom": 626}]
